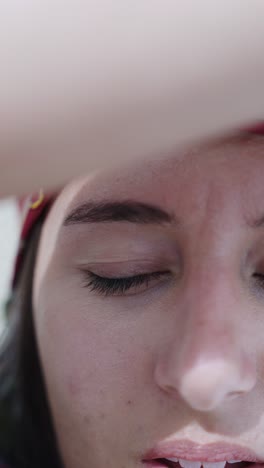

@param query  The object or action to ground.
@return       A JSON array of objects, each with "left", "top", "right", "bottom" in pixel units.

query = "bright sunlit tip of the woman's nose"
[{"left": 179, "top": 360, "right": 255, "bottom": 411}]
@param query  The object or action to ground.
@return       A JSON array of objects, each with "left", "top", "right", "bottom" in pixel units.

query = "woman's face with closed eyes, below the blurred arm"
[{"left": 34, "top": 139, "right": 264, "bottom": 468}]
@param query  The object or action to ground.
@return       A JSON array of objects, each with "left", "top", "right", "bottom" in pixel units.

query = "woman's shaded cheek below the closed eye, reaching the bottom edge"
[{"left": 35, "top": 290, "right": 160, "bottom": 468}]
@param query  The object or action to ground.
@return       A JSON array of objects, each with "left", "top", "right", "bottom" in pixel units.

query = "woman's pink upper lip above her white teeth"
[{"left": 143, "top": 440, "right": 264, "bottom": 463}]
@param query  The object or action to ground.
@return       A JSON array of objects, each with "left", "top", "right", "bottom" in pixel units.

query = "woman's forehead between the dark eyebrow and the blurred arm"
[{"left": 60, "top": 138, "right": 264, "bottom": 210}]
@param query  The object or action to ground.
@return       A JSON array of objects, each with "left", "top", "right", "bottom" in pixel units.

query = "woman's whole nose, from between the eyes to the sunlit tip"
[{"left": 155, "top": 268, "right": 256, "bottom": 411}]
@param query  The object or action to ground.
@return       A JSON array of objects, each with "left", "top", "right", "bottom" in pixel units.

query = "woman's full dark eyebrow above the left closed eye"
[{"left": 63, "top": 200, "right": 175, "bottom": 226}]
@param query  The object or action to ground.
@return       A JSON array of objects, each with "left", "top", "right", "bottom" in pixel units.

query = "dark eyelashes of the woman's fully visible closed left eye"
[{"left": 80, "top": 271, "right": 169, "bottom": 297}]
